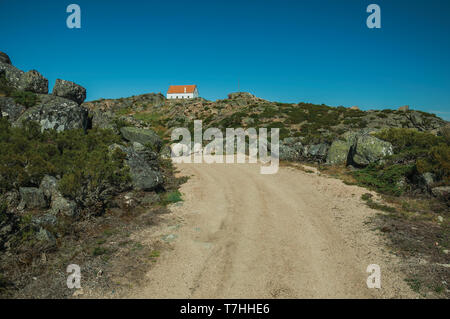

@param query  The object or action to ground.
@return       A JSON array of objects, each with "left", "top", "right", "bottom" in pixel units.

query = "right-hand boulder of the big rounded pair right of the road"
[{"left": 352, "top": 135, "right": 394, "bottom": 166}]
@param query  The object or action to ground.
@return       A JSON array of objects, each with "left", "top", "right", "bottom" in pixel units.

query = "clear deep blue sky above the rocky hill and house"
[{"left": 0, "top": 0, "right": 450, "bottom": 119}]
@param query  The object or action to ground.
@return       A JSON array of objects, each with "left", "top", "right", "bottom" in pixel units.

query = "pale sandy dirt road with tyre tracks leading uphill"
[{"left": 128, "top": 164, "right": 416, "bottom": 298}]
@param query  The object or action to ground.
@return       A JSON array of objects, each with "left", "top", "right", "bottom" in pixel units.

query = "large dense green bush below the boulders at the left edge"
[{"left": 0, "top": 119, "right": 130, "bottom": 204}]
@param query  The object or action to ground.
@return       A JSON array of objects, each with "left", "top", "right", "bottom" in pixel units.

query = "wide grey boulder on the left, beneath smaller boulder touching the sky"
[{"left": 14, "top": 94, "right": 87, "bottom": 132}]
